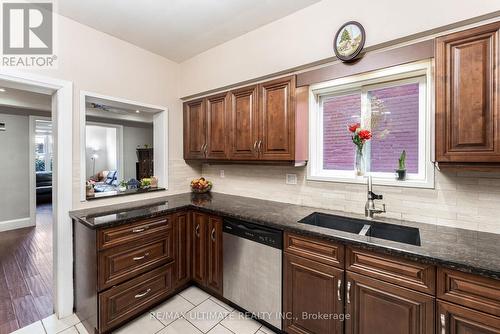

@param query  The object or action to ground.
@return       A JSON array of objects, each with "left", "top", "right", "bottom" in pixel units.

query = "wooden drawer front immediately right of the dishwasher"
[{"left": 285, "top": 233, "right": 344, "bottom": 269}]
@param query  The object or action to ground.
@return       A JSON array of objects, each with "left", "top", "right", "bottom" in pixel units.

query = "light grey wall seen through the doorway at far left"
[{"left": 0, "top": 109, "right": 30, "bottom": 222}]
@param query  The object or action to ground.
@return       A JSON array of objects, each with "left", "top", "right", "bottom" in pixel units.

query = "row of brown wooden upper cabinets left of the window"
[{"left": 184, "top": 76, "right": 308, "bottom": 164}]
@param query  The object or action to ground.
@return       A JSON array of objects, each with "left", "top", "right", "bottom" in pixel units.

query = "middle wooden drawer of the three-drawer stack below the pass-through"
[{"left": 98, "top": 233, "right": 173, "bottom": 290}]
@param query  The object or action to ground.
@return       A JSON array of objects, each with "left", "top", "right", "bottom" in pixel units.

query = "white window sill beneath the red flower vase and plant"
[{"left": 306, "top": 175, "right": 435, "bottom": 189}]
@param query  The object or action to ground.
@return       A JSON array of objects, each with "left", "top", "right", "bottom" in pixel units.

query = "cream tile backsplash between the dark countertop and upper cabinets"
[{"left": 202, "top": 165, "right": 500, "bottom": 234}]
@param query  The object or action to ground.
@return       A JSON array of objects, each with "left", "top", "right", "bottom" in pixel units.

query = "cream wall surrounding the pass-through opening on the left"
[{"left": 24, "top": 16, "right": 200, "bottom": 209}]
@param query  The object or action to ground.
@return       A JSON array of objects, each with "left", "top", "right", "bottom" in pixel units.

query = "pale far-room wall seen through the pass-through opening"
[{"left": 123, "top": 125, "right": 154, "bottom": 180}]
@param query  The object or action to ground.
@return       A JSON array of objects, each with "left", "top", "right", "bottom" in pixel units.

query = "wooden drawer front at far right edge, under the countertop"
[{"left": 437, "top": 268, "right": 500, "bottom": 316}]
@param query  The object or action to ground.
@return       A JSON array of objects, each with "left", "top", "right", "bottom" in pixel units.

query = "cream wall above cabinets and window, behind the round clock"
[{"left": 180, "top": 0, "right": 500, "bottom": 96}]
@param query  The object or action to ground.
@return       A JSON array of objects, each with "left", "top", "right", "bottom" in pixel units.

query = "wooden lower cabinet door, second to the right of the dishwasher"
[{"left": 345, "top": 272, "right": 435, "bottom": 334}]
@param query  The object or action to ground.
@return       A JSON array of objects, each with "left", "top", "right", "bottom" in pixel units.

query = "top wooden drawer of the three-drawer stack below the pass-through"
[{"left": 97, "top": 216, "right": 172, "bottom": 250}]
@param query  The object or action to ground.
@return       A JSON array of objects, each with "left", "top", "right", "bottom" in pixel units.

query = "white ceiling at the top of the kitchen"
[{"left": 57, "top": 0, "right": 320, "bottom": 62}]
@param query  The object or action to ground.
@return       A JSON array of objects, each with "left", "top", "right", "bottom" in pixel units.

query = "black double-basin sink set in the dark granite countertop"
[{"left": 299, "top": 212, "right": 420, "bottom": 246}]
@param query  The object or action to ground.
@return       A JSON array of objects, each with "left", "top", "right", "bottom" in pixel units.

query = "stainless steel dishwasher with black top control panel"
[{"left": 223, "top": 219, "right": 283, "bottom": 330}]
